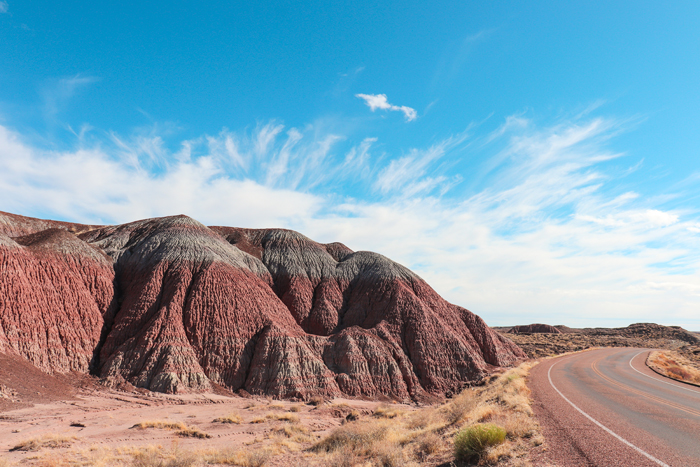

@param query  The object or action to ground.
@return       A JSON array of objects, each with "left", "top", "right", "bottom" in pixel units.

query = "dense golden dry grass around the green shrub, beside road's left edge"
[{"left": 311, "top": 363, "right": 542, "bottom": 466}]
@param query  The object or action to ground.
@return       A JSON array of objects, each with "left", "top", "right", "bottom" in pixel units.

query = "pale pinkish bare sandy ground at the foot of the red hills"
[{"left": 0, "top": 380, "right": 414, "bottom": 465}]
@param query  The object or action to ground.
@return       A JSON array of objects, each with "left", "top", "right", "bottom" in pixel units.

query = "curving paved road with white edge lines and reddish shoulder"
[{"left": 529, "top": 348, "right": 700, "bottom": 467}]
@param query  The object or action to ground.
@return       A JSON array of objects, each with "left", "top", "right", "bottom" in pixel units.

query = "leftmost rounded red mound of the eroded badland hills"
[{"left": 0, "top": 228, "right": 114, "bottom": 372}]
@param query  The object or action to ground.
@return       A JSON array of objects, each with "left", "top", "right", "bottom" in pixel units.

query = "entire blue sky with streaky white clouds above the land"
[{"left": 0, "top": 0, "right": 700, "bottom": 331}]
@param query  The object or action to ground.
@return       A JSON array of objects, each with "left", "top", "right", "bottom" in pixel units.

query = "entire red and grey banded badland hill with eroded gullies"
[{"left": 0, "top": 212, "right": 525, "bottom": 399}]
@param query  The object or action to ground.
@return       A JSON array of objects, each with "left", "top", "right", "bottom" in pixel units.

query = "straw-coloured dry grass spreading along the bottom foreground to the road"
[{"left": 0, "top": 363, "right": 542, "bottom": 467}]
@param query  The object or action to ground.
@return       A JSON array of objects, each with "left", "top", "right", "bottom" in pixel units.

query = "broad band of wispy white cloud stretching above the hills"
[{"left": 0, "top": 115, "right": 700, "bottom": 330}]
